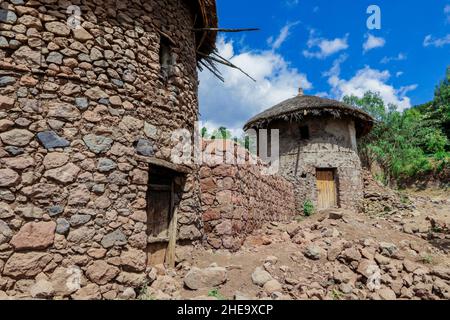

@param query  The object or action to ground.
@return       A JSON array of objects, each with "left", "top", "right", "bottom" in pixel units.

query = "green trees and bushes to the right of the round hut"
[{"left": 344, "top": 68, "right": 450, "bottom": 183}]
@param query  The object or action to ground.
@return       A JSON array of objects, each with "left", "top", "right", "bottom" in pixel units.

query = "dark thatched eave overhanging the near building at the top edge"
[{"left": 187, "top": 0, "right": 219, "bottom": 60}]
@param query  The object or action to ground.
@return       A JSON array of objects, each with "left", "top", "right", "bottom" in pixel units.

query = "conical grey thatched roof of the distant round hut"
[{"left": 244, "top": 95, "right": 375, "bottom": 136}]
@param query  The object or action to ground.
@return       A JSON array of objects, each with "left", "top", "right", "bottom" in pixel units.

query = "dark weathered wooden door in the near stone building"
[{"left": 147, "top": 185, "right": 173, "bottom": 266}]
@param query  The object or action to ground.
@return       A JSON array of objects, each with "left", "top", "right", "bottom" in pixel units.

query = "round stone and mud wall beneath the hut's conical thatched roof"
[{"left": 270, "top": 117, "right": 363, "bottom": 210}]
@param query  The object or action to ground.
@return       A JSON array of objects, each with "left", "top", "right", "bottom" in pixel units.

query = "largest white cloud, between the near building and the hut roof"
[{"left": 199, "top": 37, "right": 312, "bottom": 133}]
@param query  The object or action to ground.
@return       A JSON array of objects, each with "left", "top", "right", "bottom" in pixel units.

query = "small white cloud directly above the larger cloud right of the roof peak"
[{"left": 303, "top": 30, "right": 349, "bottom": 59}]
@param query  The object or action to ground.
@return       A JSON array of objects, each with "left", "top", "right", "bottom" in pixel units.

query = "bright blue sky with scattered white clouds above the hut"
[{"left": 199, "top": 0, "right": 450, "bottom": 134}]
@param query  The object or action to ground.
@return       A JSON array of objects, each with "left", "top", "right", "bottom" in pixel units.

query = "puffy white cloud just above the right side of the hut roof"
[{"left": 325, "top": 56, "right": 417, "bottom": 110}]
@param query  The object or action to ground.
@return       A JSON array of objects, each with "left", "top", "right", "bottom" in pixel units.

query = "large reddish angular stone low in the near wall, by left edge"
[{"left": 11, "top": 221, "right": 56, "bottom": 250}]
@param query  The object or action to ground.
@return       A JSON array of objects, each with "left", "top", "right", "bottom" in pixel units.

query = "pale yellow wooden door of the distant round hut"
[{"left": 316, "top": 170, "right": 337, "bottom": 210}]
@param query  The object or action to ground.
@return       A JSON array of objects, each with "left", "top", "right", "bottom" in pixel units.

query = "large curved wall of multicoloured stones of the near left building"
[{"left": 0, "top": 0, "right": 215, "bottom": 299}]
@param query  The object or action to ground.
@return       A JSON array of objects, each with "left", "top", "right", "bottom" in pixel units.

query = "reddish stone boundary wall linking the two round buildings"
[{"left": 200, "top": 141, "right": 297, "bottom": 251}]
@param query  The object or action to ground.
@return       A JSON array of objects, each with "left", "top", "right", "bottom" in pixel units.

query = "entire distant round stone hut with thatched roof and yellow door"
[{"left": 244, "top": 89, "right": 374, "bottom": 210}]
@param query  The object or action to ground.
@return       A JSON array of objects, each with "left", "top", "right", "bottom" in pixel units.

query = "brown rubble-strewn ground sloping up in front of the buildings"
[{"left": 139, "top": 190, "right": 450, "bottom": 300}]
